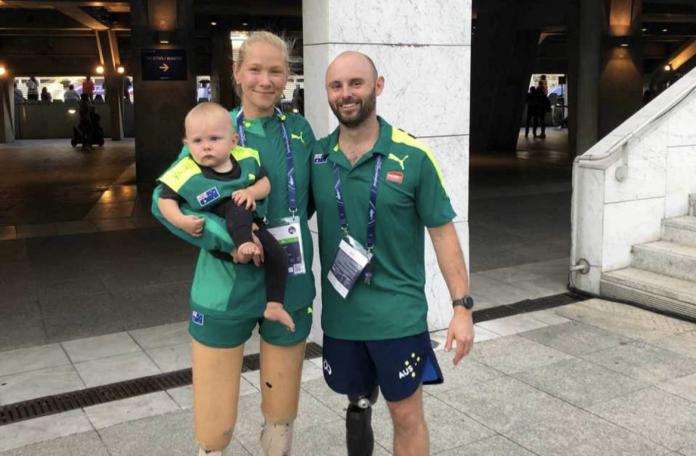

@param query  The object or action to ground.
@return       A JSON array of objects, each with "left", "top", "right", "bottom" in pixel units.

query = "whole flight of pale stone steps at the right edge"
[{"left": 600, "top": 208, "right": 696, "bottom": 319}]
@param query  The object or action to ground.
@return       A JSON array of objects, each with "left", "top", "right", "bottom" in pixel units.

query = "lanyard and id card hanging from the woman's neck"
[{"left": 236, "top": 108, "right": 307, "bottom": 276}]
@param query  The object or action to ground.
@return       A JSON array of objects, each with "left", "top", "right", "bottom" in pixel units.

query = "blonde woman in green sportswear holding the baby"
[{"left": 152, "top": 32, "right": 315, "bottom": 455}]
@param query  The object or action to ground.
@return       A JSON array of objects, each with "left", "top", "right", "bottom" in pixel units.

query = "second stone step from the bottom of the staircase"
[{"left": 631, "top": 241, "right": 696, "bottom": 280}]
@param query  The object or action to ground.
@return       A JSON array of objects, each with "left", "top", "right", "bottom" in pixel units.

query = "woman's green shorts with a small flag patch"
[{"left": 189, "top": 306, "right": 312, "bottom": 348}]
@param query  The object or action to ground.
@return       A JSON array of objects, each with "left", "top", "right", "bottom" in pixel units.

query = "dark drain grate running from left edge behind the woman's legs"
[{"left": 0, "top": 342, "right": 321, "bottom": 426}]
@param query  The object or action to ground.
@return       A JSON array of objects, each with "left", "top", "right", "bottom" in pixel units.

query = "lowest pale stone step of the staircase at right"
[{"left": 599, "top": 268, "right": 696, "bottom": 319}]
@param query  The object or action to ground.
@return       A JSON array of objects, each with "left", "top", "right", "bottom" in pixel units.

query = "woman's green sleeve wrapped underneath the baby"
[{"left": 151, "top": 185, "right": 234, "bottom": 252}]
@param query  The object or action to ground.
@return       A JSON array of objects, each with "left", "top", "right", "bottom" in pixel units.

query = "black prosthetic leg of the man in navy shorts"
[{"left": 346, "top": 386, "right": 379, "bottom": 456}]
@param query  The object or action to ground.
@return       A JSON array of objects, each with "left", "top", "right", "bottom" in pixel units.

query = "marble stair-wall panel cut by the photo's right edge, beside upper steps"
[{"left": 665, "top": 146, "right": 696, "bottom": 218}]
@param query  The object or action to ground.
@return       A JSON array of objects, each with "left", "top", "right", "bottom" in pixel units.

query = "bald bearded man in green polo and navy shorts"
[{"left": 312, "top": 52, "right": 474, "bottom": 456}]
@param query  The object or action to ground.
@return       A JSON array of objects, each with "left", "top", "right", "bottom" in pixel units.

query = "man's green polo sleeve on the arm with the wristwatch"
[{"left": 416, "top": 157, "right": 457, "bottom": 228}]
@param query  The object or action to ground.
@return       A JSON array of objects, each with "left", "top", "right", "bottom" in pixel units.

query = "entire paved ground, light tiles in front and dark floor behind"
[{"left": 5, "top": 130, "right": 676, "bottom": 456}]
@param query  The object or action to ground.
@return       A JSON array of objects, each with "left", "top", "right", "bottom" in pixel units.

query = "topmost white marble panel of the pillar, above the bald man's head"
[{"left": 302, "top": 0, "right": 471, "bottom": 45}]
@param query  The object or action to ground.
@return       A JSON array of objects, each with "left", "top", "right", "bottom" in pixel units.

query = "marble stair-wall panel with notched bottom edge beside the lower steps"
[{"left": 602, "top": 197, "right": 665, "bottom": 271}]
